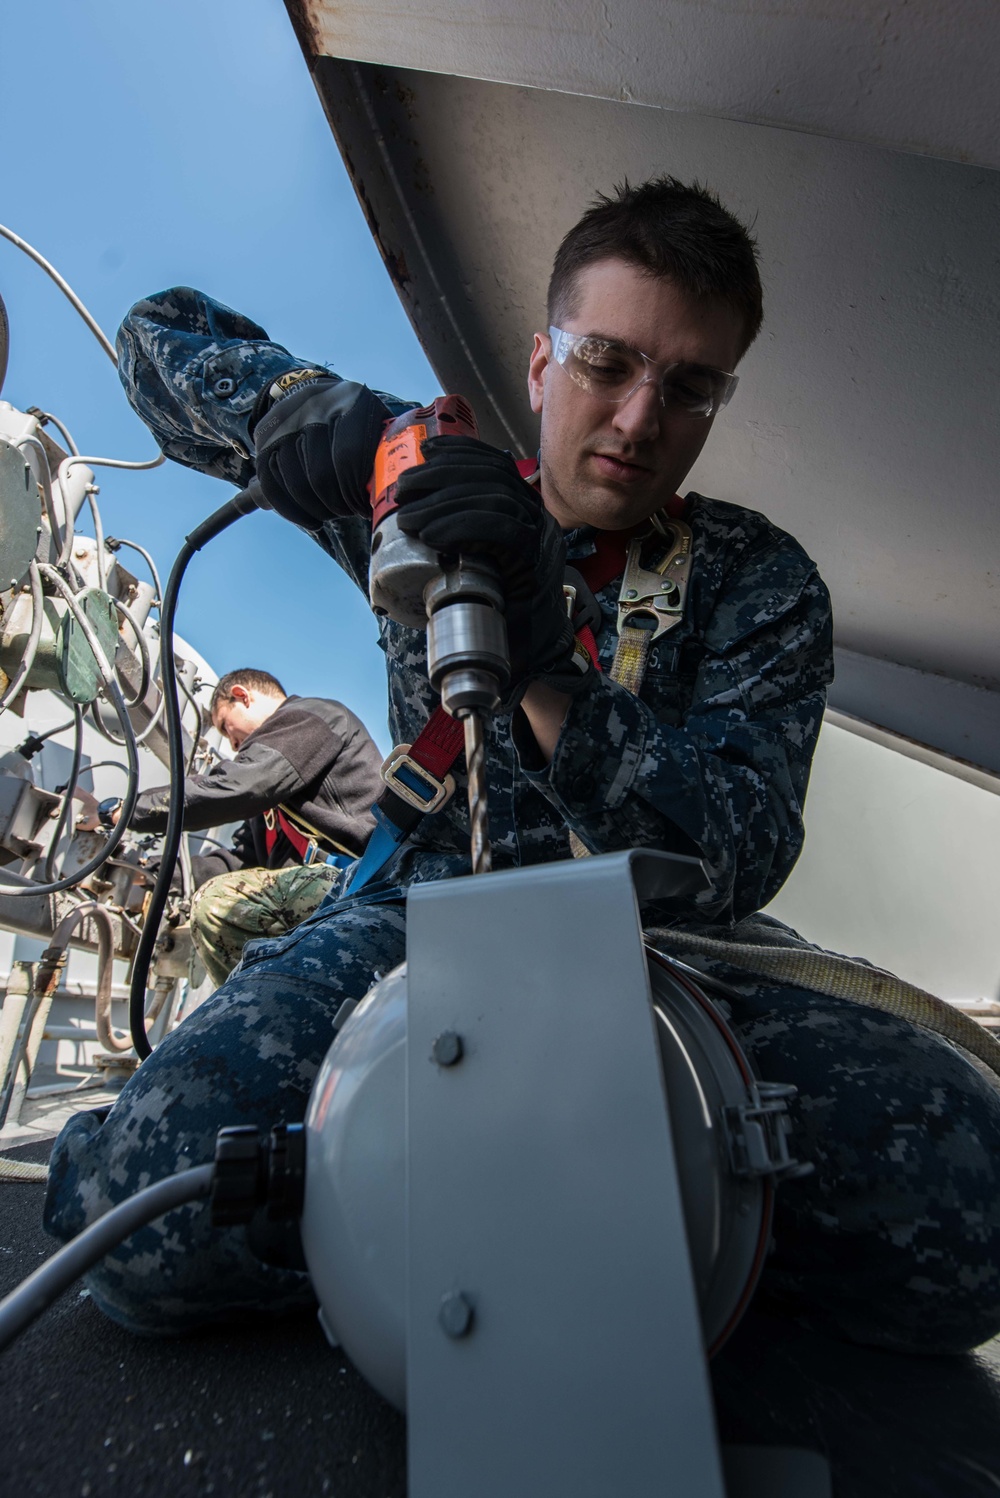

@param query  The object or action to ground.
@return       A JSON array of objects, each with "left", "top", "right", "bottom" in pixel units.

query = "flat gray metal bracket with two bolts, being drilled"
[{"left": 407, "top": 852, "right": 725, "bottom": 1498}]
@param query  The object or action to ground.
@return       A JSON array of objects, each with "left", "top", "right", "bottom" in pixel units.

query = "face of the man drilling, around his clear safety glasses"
[{"left": 528, "top": 259, "right": 743, "bottom": 530}]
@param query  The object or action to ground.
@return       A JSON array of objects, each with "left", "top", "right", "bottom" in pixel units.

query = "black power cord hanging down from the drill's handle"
[{"left": 129, "top": 481, "right": 263, "bottom": 1061}]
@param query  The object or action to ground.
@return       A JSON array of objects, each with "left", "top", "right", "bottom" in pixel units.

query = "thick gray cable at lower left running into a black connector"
[{"left": 0, "top": 1165, "right": 216, "bottom": 1351}]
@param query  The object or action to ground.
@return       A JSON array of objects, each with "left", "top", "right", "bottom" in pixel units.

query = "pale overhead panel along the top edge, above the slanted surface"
[{"left": 289, "top": 0, "right": 1000, "bottom": 166}]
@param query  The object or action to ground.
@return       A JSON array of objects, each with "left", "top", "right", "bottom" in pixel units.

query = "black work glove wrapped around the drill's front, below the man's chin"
[{"left": 397, "top": 437, "right": 590, "bottom": 712}]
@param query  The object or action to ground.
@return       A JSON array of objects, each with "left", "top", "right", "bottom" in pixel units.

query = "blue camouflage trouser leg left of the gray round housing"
[{"left": 43, "top": 896, "right": 406, "bottom": 1335}]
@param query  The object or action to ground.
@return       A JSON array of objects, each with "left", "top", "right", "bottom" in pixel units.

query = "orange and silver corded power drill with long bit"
[{"left": 368, "top": 395, "right": 510, "bottom": 873}]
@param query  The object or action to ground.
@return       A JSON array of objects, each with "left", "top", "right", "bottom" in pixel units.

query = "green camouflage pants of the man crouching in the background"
[{"left": 192, "top": 863, "right": 343, "bottom": 987}]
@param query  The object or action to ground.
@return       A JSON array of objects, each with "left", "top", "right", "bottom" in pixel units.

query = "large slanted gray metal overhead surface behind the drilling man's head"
[{"left": 281, "top": 11, "right": 1000, "bottom": 771}]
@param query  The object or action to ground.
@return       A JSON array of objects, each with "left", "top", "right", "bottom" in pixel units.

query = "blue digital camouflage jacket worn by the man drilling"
[{"left": 118, "top": 288, "right": 832, "bottom": 923}]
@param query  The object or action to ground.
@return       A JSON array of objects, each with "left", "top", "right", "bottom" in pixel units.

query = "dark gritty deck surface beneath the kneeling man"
[{"left": 0, "top": 1141, "right": 1000, "bottom": 1498}]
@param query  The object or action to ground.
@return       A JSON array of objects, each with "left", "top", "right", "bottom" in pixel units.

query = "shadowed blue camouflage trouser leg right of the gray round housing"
[{"left": 688, "top": 958, "right": 1000, "bottom": 1353}]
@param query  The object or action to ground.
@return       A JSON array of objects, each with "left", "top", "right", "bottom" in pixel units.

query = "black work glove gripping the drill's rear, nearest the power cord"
[{"left": 253, "top": 375, "right": 391, "bottom": 530}]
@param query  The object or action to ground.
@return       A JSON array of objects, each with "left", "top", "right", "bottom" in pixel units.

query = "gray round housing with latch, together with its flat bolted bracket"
[{"left": 293, "top": 851, "right": 829, "bottom": 1498}]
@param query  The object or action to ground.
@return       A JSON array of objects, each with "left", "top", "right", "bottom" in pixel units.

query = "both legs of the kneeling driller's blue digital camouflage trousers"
[{"left": 45, "top": 902, "right": 1000, "bottom": 1353}]
